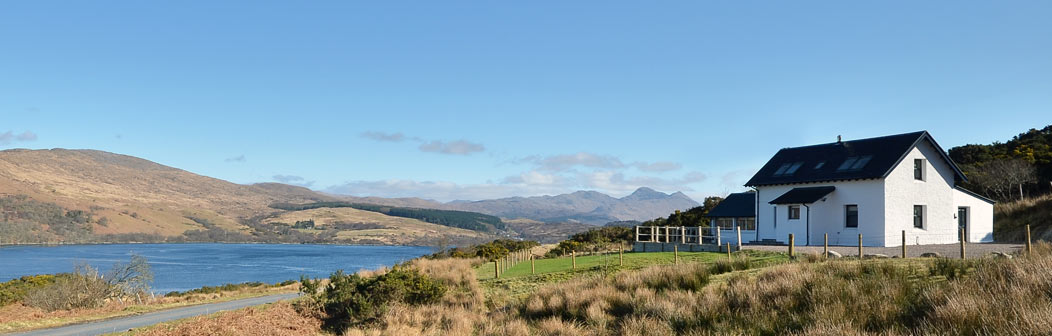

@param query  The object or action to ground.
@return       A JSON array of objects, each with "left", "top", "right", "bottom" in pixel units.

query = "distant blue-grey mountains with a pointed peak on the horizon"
[{"left": 445, "top": 187, "right": 699, "bottom": 224}]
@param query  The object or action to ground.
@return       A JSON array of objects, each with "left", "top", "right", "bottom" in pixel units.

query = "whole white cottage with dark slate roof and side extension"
[{"left": 742, "top": 132, "right": 993, "bottom": 246}]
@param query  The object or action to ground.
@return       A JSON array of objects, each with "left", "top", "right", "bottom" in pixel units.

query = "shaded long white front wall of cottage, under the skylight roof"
[{"left": 756, "top": 180, "right": 885, "bottom": 246}]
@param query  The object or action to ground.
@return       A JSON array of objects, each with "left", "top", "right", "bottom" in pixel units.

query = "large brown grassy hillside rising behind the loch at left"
[{"left": 0, "top": 149, "right": 489, "bottom": 244}]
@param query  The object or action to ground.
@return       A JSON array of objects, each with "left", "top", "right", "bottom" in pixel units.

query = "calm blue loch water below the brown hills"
[{"left": 0, "top": 243, "right": 431, "bottom": 293}]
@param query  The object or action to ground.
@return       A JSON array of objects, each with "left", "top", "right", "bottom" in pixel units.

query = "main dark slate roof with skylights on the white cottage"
[{"left": 745, "top": 131, "right": 967, "bottom": 186}]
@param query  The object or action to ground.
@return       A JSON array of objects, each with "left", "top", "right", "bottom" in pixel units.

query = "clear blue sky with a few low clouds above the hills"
[{"left": 0, "top": 1, "right": 1052, "bottom": 200}]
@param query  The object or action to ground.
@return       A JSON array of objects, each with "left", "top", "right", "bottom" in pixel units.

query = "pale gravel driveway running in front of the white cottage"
[{"left": 743, "top": 243, "right": 1023, "bottom": 258}]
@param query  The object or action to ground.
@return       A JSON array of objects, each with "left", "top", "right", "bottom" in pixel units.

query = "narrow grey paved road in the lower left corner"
[{"left": 9, "top": 293, "right": 300, "bottom": 336}]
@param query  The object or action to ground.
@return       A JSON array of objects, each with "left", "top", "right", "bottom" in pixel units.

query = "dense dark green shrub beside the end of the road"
[{"left": 301, "top": 265, "right": 446, "bottom": 332}]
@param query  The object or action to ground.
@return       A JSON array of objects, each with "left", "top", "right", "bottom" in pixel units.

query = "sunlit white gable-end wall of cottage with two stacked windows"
[{"left": 884, "top": 141, "right": 959, "bottom": 246}]
